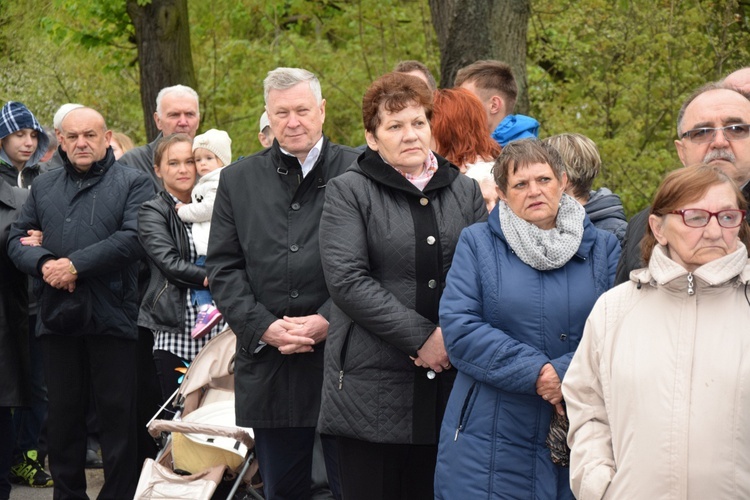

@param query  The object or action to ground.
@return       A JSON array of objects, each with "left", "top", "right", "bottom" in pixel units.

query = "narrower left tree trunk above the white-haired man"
[{"left": 127, "top": 0, "right": 198, "bottom": 142}]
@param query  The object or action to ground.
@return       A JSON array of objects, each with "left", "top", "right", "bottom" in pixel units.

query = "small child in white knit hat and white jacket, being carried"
[{"left": 177, "top": 128, "right": 232, "bottom": 338}]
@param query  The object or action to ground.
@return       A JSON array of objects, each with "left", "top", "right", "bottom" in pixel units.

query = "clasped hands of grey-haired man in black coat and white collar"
[{"left": 260, "top": 314, "right": 328, "bottom": 354}]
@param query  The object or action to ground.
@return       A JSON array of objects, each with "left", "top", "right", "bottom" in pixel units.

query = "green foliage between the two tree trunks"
[{"left": 190, "top": 0, "right": 439, "bottom": 156}]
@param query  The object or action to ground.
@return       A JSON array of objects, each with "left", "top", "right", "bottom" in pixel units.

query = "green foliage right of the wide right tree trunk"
[{"left": 529, "top": 0, "right": 750, "bottom": 214}]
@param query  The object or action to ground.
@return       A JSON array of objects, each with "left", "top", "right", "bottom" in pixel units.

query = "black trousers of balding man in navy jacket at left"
[{"left": 41, "top": 335, "right": 138, "bottom": 500}]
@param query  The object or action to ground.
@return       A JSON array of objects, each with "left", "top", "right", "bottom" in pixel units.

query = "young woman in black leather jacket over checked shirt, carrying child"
[{"left": 138, "top": 134, "right": 228, "bottom": 400}]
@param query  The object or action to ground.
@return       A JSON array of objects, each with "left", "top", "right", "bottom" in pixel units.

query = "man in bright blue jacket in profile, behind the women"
[{"left": 455, "top": 60, "right": 539, "bottom": 146}]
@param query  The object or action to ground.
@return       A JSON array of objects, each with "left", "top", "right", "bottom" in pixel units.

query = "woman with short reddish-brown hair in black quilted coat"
[{"left": 319, "top": 73, "right": 487, "bottom": 500}]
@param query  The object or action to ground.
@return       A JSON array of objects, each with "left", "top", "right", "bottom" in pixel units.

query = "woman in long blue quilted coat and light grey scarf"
[{"left": 435, "top": 139, "right": 620, "bottom": 499}]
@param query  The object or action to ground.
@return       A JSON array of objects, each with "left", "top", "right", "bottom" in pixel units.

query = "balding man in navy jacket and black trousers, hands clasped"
[{"left": 8, "top": 107, "right": 154, "bottom": 498}]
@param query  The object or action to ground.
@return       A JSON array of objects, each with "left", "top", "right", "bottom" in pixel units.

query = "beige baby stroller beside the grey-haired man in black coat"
[{"left": 135, "top": 328, "right": 263, "bottom": 500}]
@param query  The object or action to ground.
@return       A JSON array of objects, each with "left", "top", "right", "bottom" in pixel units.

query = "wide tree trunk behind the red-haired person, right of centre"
[{"left": 429, "top": 0, "right": 531, "bottom": 114}]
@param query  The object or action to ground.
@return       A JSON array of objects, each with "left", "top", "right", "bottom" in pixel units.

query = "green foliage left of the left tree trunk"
[{"left": 0, "top": 0, "right": 142, "bottom": 138}]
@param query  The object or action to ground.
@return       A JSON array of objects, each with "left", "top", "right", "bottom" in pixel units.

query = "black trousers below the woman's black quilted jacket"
[{"left": 336, "top": 436, "right": 437, "bottom": 500}]
